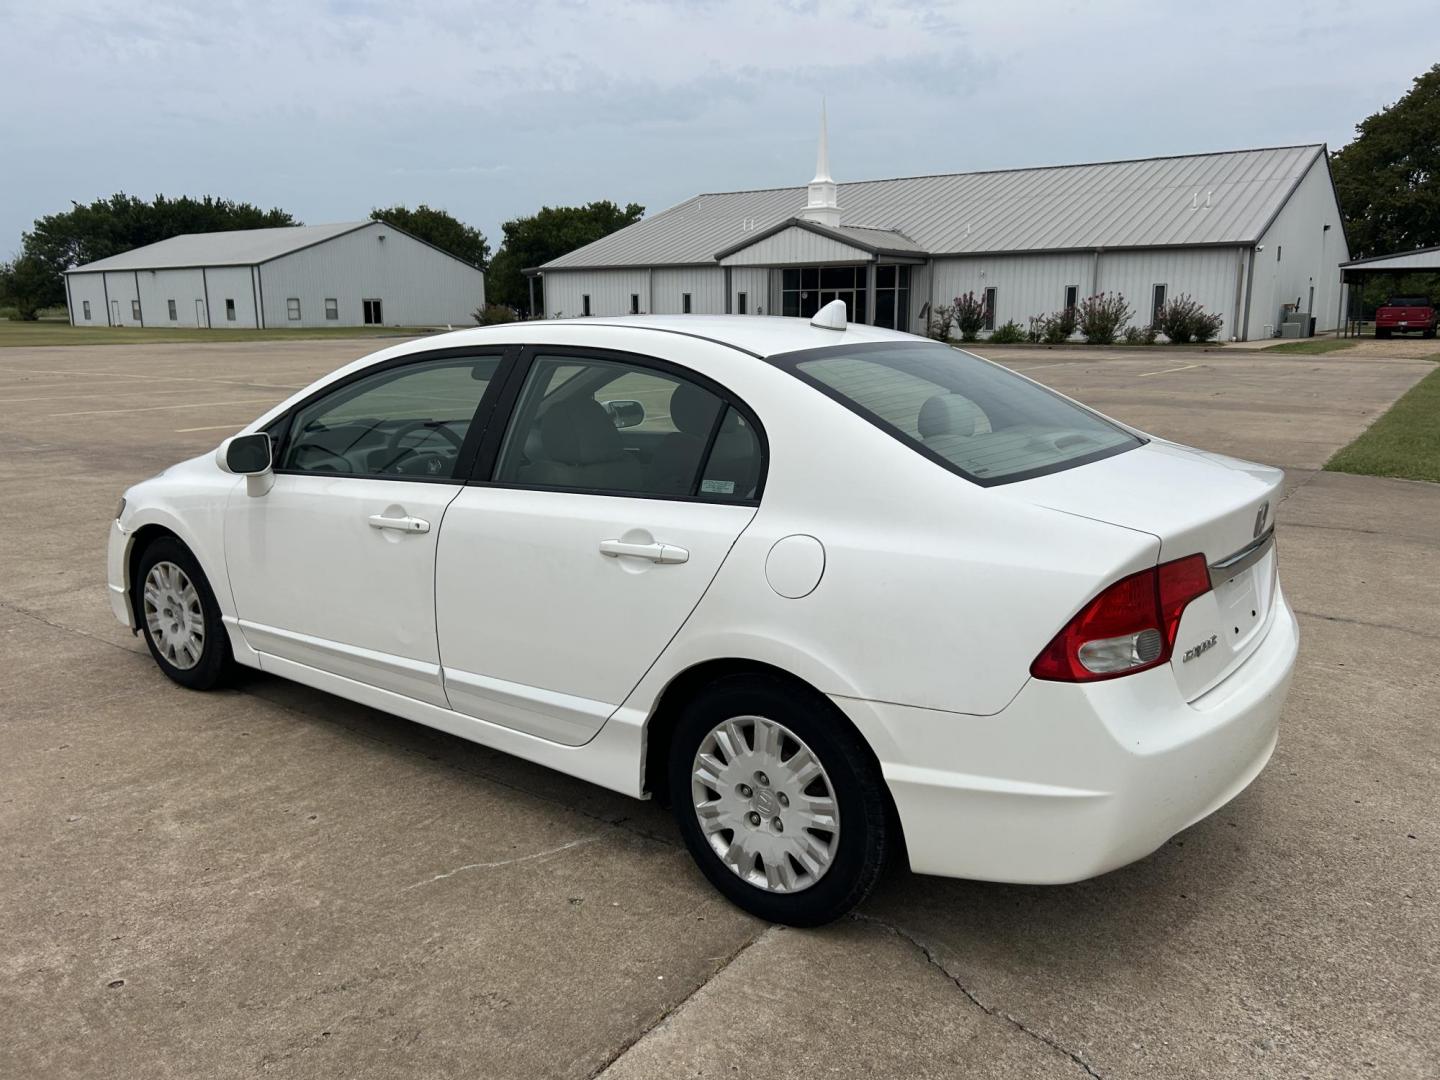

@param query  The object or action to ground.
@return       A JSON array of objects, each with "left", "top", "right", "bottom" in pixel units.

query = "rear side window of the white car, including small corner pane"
[{"left": 495, "top": 356, "right": 762, "bottom": 501}]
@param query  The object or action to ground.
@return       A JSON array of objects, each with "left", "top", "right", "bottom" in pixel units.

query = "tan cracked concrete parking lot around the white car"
[{"left": 0, "top": 340, "right": 1440, "bottom": 1080}]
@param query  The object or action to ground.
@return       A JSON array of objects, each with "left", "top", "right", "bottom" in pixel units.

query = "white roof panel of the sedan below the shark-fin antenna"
[{"left": 417, "top": 315, "right": 922, "bottom": 357}]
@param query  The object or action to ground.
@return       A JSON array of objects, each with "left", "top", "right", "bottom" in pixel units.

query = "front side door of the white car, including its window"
[{"left": 225, "top": 350, "right": 503, "bottom": 707}]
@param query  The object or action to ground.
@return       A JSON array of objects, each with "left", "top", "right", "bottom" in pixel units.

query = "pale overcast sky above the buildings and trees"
[{"left": 0, "top": 0, "right": 1440, "bottom": 255}]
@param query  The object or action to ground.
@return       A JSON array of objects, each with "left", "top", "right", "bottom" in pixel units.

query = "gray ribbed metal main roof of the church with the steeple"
[{"left": 540, "top": 144, "right": 1325, "bottom": 271}]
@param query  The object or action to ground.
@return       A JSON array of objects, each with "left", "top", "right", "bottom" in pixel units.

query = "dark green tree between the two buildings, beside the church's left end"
[{"left": 485, "top": 199, "right": 645, "bottom": 318}]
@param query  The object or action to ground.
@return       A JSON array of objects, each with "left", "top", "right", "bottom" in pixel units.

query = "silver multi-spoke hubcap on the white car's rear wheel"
[{"left": 690, "top": 716, "right": 840, "bottom": 893}]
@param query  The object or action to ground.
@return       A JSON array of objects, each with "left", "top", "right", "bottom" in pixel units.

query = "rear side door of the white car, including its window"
[{"left": 435, "top": 348, "right": 765, "bottom": 746}]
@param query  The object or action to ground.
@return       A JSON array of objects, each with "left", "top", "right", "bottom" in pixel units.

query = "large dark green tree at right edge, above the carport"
[{"left": 1331, "top": 63, "right": 1440, "bottom": 258}]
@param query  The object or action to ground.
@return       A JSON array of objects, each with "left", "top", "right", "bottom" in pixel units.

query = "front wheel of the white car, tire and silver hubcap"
[{"left": 135, "top": 536, "right": 235, "bottom": 690}]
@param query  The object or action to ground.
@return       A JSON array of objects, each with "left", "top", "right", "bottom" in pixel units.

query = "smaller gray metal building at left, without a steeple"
[{"left": 65, "top": 222, "right": 485, "bottom": 330}]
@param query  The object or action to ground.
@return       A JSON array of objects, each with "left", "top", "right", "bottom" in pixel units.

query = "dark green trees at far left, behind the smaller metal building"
[{"left": 12, "top": 192, "right": 300, "bottom": 316}]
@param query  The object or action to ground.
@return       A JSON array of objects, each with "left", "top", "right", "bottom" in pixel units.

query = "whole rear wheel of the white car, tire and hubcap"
[{"left": 670, "top": 675, "right": 890, "bottom": 926}]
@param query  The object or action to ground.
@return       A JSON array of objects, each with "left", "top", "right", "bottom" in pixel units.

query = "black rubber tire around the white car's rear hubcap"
[{"left": 668, "top": 675, "right": 891, "bottom": 926}]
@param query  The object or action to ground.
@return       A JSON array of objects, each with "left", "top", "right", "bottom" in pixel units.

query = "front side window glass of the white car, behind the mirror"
[{"left": 282, "top": 357, "right": 500, "bottom": 480}]
